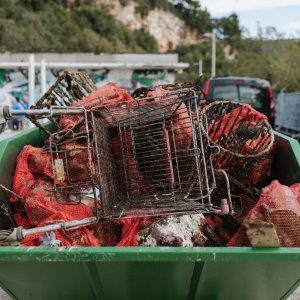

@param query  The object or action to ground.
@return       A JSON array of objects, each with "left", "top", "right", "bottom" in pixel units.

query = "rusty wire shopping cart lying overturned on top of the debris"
[{"left": 43, "top": 89, "right": 237, "bottom": 219}]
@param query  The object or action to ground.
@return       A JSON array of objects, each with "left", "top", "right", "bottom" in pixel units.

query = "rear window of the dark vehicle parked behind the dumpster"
[{"left": 212, "top": 84, "right": 267, "bottom": 109}]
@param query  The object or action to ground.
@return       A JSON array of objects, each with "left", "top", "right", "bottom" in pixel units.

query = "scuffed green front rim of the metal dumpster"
[{"left": 0, "top": 247, "right": 300, "bottom": 262}]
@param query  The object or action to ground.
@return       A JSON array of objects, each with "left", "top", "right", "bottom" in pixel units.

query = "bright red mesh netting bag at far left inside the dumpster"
[{"left": 11, "top": 145, "right": 100, "bottom": 246}]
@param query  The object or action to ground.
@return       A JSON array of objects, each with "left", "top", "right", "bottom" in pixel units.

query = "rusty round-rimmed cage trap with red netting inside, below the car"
[{"left": 201, "top": 101, "right": 274, "bottom": 191}]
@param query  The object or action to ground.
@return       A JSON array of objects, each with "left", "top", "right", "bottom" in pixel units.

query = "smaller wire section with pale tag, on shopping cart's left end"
[{"left": 46, "top": 107, "right": 99, "bottom": 212}]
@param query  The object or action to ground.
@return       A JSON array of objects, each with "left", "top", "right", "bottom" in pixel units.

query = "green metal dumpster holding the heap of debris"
[{"left": 0, "top": 129, "right": 300, "bottom": 300}]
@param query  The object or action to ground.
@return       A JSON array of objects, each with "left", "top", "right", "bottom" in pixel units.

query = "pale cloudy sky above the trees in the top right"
[{"left": 200, "top": 0, "right": 300, "bottom": 37}]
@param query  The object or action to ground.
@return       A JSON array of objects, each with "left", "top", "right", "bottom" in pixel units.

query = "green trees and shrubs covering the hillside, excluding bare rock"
[{"left": 0, "top": 0, "right": 300, "bottom": 91}]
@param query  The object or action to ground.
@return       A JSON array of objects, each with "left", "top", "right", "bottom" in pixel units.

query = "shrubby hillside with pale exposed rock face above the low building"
[{"left": 0, "top": 0, "right": 212, "bottom": 53}]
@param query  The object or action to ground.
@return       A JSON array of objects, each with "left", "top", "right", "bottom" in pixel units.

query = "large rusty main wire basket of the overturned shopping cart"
[{"left": 91, "top": 89, "right": 227, "bottom": 218}]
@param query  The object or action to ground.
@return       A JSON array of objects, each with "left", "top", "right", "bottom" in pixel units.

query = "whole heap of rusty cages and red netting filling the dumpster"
[{"left": 0, "top": 72, "right": 300, "bottom": 247}]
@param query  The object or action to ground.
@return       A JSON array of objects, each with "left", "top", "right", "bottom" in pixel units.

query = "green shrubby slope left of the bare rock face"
[{"left": 0, "top": 0, "right": 157, "bottom": 53}]
